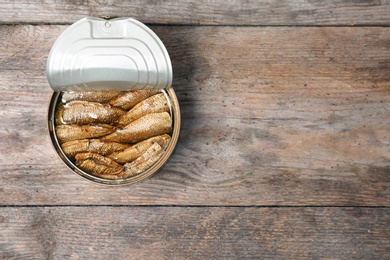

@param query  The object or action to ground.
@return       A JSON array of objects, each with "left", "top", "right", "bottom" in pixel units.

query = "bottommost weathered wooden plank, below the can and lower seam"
[{"left": 0, "top": 207, "right": 390, "bottom": 259}]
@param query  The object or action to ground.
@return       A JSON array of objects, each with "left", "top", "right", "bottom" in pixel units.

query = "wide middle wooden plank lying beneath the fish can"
[{"left": 0, "top": 25, "right": 390, "bottom": 206}]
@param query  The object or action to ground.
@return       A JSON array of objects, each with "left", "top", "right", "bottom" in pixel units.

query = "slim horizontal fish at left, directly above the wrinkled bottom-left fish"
[{"left": 61, "top": 139, "right": 129, "bottom": 158}]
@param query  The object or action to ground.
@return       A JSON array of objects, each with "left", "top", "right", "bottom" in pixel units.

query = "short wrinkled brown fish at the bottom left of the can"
[{"left": 75, "top": 153, "right": 123, "bottom": 178}]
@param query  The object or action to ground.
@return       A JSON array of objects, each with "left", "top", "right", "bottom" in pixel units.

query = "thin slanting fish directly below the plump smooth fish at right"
[{"left": 107, "top": 134, "right": 171, "bottom": 164}]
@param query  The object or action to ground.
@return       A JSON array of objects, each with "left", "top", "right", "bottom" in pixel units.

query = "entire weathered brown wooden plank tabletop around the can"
[{"left": 0, "top": 0, "right": 390, "bottom": 259}]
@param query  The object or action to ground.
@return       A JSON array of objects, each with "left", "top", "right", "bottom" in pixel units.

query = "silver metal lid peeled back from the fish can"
[{"left": 46, "top": 18, "right": 172, "bottom": 91}]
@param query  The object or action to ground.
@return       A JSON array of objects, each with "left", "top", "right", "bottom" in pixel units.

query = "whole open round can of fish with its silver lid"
[{"left": 46, "top": 18, "right": 180, "bottom": 185}]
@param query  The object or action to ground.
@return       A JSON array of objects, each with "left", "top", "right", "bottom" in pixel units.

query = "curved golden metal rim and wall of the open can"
[{"left": 48, "top": 88, "right": 180, "bottom": 185}]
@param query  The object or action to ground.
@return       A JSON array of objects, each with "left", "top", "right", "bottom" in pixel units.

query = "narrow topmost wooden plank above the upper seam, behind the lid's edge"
[{"left": 0, "top": 0, "right": 390, "bottom": 26}]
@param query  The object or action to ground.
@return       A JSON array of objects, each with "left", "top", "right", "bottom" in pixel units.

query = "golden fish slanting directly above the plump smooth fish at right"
[{"left": 118, "top": 93, "right": 169, "bottom": 126}]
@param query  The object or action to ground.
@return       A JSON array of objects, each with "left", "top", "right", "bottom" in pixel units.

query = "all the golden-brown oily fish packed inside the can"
[{"left": 55, "top": 90, "right": 172, "bottom": 180}]
